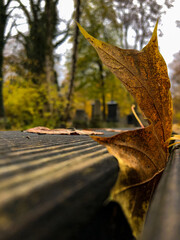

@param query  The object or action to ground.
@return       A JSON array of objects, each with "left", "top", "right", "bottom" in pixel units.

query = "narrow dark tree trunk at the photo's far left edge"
[{"left": 0, "top": 0, "right": 12, "bottom": 123}]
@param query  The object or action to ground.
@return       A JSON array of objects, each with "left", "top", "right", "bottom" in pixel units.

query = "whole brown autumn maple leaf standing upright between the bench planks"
[{"left": 77, "top": 23, "right": 172, "bottom": 237}]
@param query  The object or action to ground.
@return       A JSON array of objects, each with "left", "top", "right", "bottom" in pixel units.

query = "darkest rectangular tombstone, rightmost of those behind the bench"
[{"left": 107, "top": 101, "right": 119, "bottom": 122}]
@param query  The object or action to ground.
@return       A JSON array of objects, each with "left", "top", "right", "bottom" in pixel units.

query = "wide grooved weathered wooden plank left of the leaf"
[{"left": 0, "top": 132, "right": 118, "bottom": 240}]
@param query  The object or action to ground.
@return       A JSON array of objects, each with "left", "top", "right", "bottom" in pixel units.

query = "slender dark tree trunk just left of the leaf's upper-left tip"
[{"left": 65, "top": 0, "right": 81, "bottom": 121}]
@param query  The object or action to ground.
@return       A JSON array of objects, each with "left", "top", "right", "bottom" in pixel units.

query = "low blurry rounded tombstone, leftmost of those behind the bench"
[{"left": 73, "top": 109, "right": 89, "bottom": 128}]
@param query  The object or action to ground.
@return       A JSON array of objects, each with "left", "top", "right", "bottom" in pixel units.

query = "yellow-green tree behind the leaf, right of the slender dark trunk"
[{"left": 63, "top": 0, "right": 133, "bottom": 119}]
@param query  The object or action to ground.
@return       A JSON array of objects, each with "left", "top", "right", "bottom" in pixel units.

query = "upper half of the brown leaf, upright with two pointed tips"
[{"left": 78, "top": 23, "right": 172, "bottom": 148}]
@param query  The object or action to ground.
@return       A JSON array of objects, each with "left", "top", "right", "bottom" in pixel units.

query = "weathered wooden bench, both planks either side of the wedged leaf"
[{"left": 0, "top": 131, "right": 180, "bottom": 240}]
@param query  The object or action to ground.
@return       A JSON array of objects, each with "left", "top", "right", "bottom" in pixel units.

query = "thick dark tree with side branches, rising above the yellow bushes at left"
[{"left": 16, "top": 0, "right": 69, "bottom": 84}]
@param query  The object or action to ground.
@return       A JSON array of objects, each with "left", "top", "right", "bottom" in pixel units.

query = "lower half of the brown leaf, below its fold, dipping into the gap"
[{"left": 92, "top": 125, "right": 167, "bottom": 237}]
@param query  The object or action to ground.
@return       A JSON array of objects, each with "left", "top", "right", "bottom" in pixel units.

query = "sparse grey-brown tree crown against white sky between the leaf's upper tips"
[{"left": 112, "top": 0, "right": 174, "bottom": 50}]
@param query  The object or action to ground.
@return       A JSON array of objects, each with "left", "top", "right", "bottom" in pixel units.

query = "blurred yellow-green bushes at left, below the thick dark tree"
[{"left": 4, "top": 77, "right": 63, "bottom": 129}]
